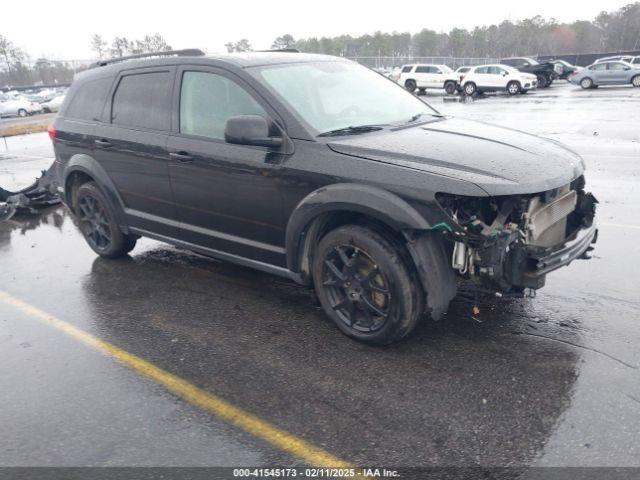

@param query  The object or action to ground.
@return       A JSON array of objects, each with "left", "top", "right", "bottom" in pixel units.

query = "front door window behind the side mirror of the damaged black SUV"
[{"left": 180, "top": 72, "right": 267, "bottom": 140}]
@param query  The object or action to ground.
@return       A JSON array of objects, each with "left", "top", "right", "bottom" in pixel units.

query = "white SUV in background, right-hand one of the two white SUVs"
[{"left": 461, "top": 64, "right": 538, "bottom": 95}]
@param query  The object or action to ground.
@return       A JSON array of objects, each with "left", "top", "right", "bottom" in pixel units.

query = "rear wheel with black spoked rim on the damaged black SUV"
[{"left": 73, "top": 182, "right": 137, "bottom": 258}]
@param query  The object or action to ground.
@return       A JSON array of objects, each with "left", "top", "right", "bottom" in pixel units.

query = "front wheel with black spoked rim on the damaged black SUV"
[{"left": 313, "top": 225, "right": 424, "bottom": 345}]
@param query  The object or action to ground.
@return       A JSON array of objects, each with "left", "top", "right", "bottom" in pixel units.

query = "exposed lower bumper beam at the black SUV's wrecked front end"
[{"left": 510, "top": 225, "right": 598, "bottom": 289}]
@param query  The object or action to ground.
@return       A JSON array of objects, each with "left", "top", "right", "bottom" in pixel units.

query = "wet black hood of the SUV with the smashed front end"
[{"left": 329, "top": 117, "right": 584, "bottom": 195}]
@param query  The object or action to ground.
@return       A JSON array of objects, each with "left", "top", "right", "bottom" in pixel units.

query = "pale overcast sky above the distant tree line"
[{"left": 0, "top": 0, "right": 632, "bottom": 59}]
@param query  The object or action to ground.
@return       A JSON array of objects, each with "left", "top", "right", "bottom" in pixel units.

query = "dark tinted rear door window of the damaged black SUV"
[{"left": 111, "top": 72, "right": 172, "bottom": 130}]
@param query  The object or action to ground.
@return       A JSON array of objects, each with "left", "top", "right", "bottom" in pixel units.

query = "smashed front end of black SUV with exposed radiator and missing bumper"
[{"left": 438, "top": 177, "right": 598, "bottom": 294}]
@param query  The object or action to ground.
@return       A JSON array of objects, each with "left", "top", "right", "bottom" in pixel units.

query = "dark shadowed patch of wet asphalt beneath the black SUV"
[{"left": 82, "top": 247, "right": 579, "bottom": 466}]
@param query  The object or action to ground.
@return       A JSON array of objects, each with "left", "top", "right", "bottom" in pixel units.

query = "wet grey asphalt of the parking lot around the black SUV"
[{"left": 0, "top": 83, "right": 640, "bottom": 466}]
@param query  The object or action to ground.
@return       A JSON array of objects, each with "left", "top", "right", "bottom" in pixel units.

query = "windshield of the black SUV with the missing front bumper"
[{"left": 252, "top": 62, "right": 438, "bottom": 134}]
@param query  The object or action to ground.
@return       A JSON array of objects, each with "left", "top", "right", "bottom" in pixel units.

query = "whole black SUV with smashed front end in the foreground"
[{"left": 50, "top": 51, "right": 597, "bottom": 344}]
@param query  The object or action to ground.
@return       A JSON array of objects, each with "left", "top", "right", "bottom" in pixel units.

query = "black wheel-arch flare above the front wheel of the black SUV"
[{"left": 286, "top": 183, "right": 430, "bottom": 273}]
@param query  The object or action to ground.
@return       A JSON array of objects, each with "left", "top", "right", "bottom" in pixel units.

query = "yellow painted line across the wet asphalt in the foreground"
[{"left": 0, "top": 290, "right": 352, "bottom": 468}]
